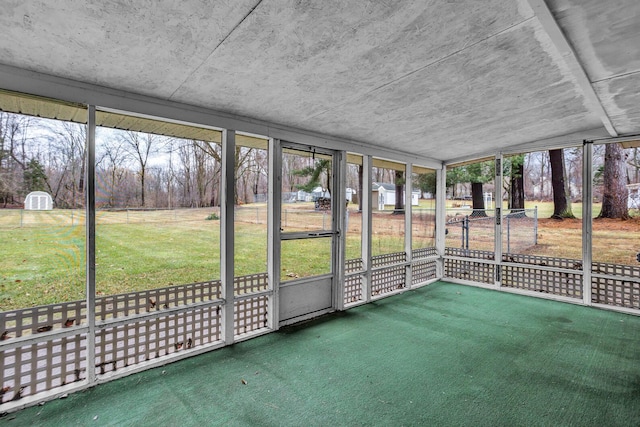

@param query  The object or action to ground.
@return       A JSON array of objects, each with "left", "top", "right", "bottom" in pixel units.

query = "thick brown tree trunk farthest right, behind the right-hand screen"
[{"left": 598, "top": 143, "right": 629, "bottom": 219}]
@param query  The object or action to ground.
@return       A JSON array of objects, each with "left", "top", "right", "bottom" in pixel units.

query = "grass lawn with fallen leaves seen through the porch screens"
[{"left": 0, "top": 201, "right": 640, "bottom": 311}]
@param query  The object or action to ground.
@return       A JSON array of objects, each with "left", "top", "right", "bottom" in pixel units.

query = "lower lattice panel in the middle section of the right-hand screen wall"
[{"left": 502, "top": 265, "right": 582, "bottom": 298}]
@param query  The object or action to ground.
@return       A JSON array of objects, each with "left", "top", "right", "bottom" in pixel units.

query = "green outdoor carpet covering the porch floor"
[{"left": 0, "top": 282, "right": 640, "bottom": 426}]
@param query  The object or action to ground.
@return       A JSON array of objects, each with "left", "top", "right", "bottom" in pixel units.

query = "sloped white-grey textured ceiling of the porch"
[{"left": 0, "top": 0, "right": 640, "bottom": 161}]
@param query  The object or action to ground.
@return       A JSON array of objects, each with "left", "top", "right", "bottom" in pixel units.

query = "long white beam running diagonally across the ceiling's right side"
[{"left": 528, "top": 0, "right": 618, "bottom": 137}]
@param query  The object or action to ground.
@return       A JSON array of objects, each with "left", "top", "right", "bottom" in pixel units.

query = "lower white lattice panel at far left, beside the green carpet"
[{"left": 0, "top": 334, "right": 87, "bottom": 403}]
